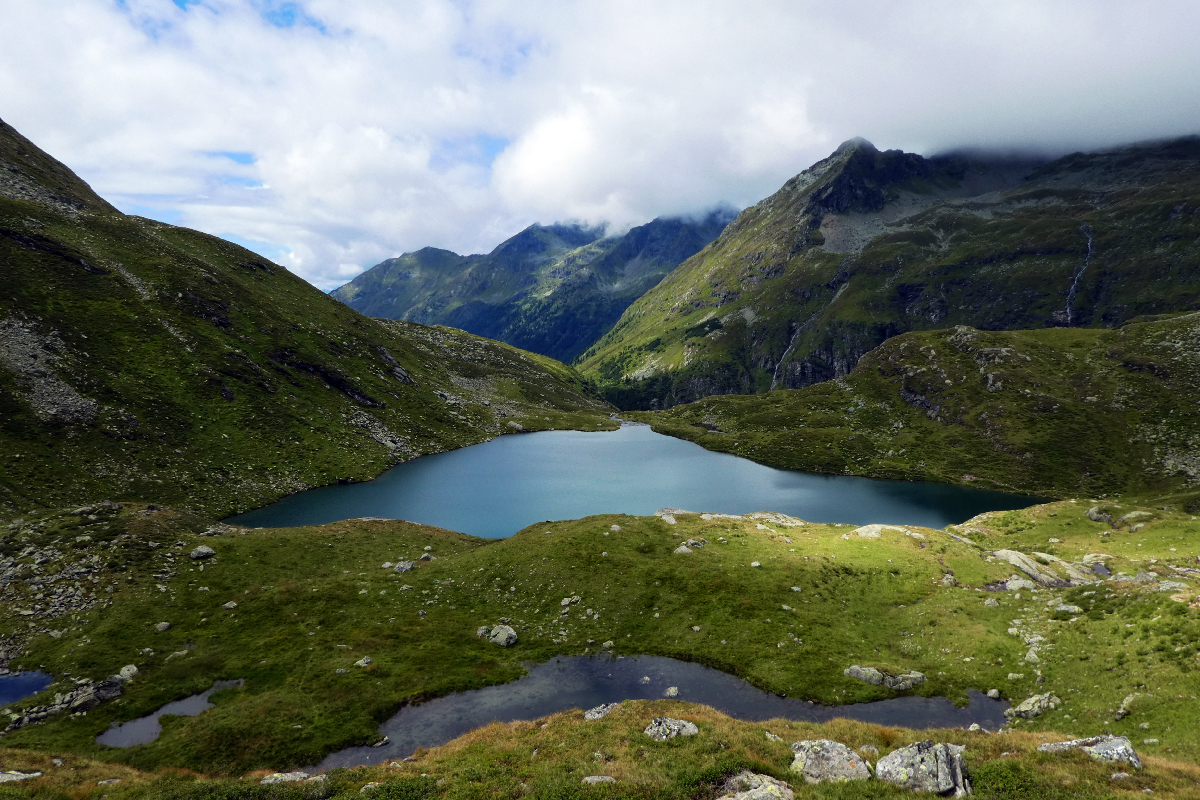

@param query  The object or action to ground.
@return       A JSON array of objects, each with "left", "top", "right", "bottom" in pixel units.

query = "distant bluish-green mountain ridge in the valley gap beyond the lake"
[{"left": 331, "top": 210, "right": 733, "bottom": 362}]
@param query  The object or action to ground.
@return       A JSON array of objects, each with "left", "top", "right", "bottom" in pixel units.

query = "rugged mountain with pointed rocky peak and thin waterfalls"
[{"left": 580, "top": 137, "right": 1200, "bottom": 408}]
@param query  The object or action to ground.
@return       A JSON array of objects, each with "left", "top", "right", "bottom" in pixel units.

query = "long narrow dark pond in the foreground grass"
[{"left": 314, "top": 655, "right": 1008, "bottom": 771}]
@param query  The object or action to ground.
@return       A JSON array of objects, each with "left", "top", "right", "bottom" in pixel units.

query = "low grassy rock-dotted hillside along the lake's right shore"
[{"left": 632, "top": 313, "right": 1200, "bottom": 500}]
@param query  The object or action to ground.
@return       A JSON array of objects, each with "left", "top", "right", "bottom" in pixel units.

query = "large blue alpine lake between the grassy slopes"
[{"left": 227, "top": 425, "right": 1042, "bottom": 539}]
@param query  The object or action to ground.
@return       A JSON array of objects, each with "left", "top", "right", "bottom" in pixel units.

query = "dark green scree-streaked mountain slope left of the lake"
[{"left": 0, "top": 122, "right": 610, "bottom": 515}]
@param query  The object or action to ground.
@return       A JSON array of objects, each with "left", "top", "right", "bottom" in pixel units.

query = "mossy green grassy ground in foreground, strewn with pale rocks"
[{"left": 0, "top": 501, "right": 1200, "bottom": 796}]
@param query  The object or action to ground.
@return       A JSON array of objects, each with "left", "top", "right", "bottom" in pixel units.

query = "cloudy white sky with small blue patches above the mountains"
[{"left": 0, "top": 0, "right": 1200, "bottom": 289}]
